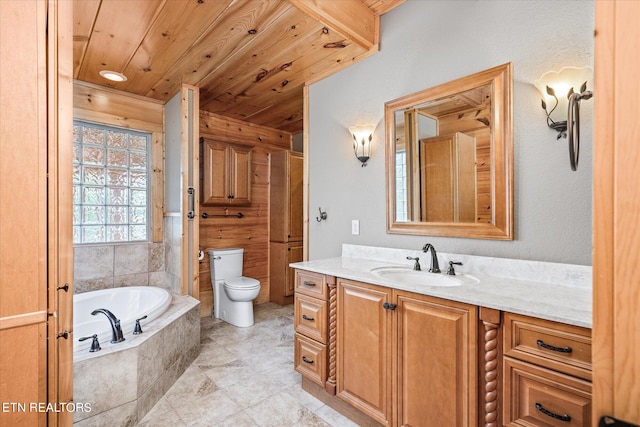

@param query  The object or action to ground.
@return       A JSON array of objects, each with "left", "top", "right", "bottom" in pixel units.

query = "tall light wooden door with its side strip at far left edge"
[{"left": 0, "top": 1, "right": 73, "bottom": 426}]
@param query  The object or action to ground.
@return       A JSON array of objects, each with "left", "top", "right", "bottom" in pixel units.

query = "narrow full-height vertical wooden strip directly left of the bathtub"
[{"left": 47, "top": 0, "right": 74, "bottom": 426}]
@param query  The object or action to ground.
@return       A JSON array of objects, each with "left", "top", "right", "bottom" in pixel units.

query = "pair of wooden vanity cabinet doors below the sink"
[{"left": 336, "top": 279, "right": 478, "bottom": 427}]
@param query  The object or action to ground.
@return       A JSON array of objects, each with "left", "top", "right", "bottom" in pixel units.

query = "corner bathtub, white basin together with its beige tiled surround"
[{"left": 73, "top": 286, "right": 200, "bottom": 426}]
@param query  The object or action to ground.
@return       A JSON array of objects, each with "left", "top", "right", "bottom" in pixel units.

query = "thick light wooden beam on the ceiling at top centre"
[{"left": 289, "top": 0, "right": 380, "bottom": 51}]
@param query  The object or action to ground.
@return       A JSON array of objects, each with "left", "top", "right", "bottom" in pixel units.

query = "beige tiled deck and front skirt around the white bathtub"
[{"left": 73, "top": 295, "right": 200, "bottom": 427}]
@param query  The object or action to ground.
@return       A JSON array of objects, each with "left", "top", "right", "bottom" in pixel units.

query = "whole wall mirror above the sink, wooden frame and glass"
[{"left": 385, "top": 63, "right": 513, "bottom": 240}]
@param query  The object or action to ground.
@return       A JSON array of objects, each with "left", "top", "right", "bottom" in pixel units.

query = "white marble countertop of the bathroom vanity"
[{"left": 290, "top": 253, "right": 592, "bottom": 328}]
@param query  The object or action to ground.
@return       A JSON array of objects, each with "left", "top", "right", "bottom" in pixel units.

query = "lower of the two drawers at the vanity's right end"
[{"left": 504, "top": 357, "right": 591, "bottom": 427}]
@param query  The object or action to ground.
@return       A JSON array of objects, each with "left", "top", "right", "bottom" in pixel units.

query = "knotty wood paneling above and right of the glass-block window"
[{"left": 73, "top": 80, "right": 164, "bottom": 242}]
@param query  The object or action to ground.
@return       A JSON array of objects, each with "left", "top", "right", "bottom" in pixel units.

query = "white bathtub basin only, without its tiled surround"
[{"left": 73, "top": 286, "right": 171, "bottom": 353}]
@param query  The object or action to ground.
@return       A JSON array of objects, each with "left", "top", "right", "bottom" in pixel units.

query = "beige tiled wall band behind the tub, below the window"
[{"left": 73, "top": 215, "right": 182, "bottom": 294}]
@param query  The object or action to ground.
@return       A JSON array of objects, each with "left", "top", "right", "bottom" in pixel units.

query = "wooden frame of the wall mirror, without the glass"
[{"left": 385, "top": 62, "right": 513, "bottom": 240}]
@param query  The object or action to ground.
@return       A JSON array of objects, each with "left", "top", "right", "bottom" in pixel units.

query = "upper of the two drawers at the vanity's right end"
[{"left": 504, "top": 313, "right": 591, "bottom": 381}]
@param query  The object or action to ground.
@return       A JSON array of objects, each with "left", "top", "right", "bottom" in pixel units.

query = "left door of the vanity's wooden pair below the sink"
[{"left": 336, "top": 279, "right": 393, "bottom": 425}]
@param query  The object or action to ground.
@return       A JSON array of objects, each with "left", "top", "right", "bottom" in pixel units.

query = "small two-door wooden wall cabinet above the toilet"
[{"left": 200, "top": 138, "right": 252, "bottom": 206}]
